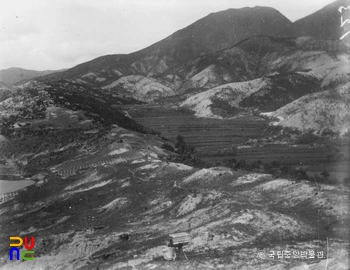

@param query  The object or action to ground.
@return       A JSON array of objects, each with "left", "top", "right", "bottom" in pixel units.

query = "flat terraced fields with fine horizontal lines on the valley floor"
[{"left": 119, "top": 104, "right": 341, "bottom": 164}]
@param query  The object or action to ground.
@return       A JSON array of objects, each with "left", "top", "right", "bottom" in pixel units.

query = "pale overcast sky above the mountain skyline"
[{"left": 0, "top": 0, "right": 333, "bottom": 70}]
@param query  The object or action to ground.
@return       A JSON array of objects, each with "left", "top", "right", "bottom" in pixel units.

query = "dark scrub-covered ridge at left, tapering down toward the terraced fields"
[{"left": 0, "top": 77, "right": 158, "bottom": 136}]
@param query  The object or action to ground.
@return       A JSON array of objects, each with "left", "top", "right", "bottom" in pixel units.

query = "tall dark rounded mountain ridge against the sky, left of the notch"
[{"left": 41, "top": 7, "right": 294, "bottom": 83}]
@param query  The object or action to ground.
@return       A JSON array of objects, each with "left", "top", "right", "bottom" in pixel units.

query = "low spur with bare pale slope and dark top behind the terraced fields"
[{"left": 181, "top": 73, "right": 320, "bottom": 117}]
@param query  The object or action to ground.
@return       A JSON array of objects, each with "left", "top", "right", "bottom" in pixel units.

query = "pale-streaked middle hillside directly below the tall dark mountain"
[{"left": 168, "top": 36, "right": 349, "bottom": 93}]
